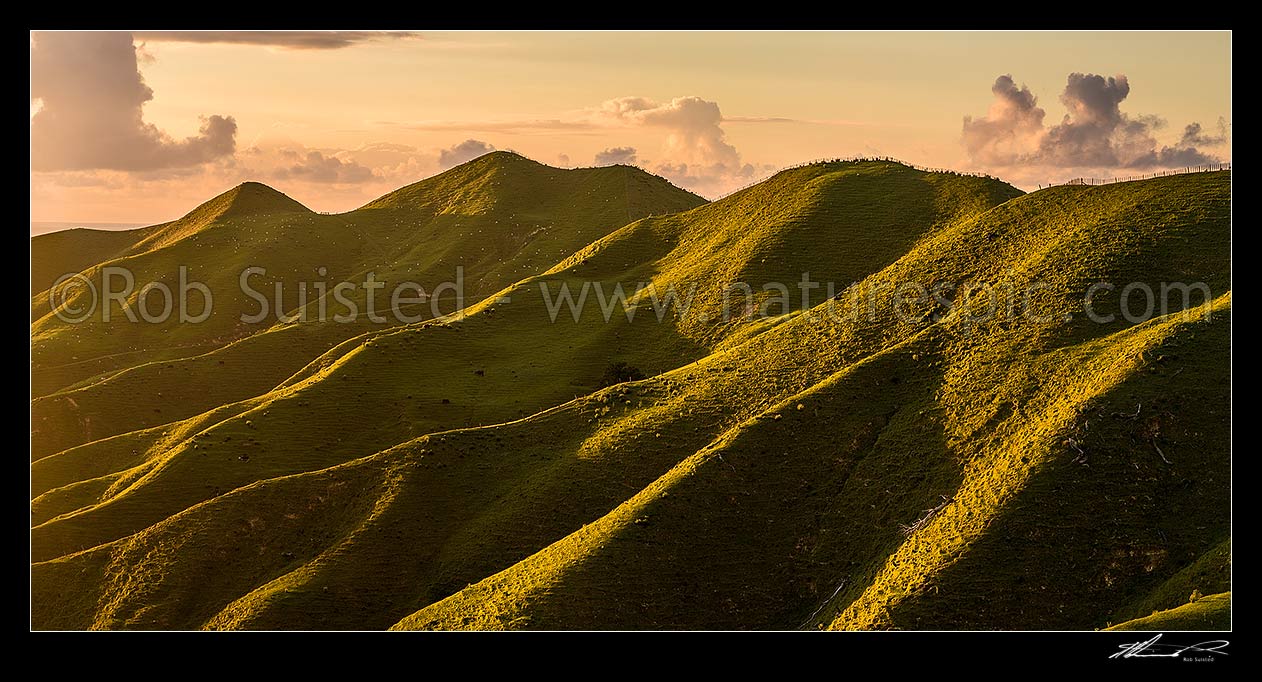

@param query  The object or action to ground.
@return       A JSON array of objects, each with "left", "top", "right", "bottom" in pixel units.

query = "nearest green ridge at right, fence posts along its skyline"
[{"left": 399, "top": 177, "right": 1230, "bottom": 629}]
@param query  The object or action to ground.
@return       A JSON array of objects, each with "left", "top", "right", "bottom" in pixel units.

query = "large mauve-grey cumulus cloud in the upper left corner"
[{"left": 30, "top": 32, "right": 237, "bottom": 171}]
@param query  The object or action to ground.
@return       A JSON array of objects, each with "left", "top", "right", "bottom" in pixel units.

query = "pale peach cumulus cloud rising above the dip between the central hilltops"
[{"left": 599, "top": 96, "right": 755, "bottom": 196}]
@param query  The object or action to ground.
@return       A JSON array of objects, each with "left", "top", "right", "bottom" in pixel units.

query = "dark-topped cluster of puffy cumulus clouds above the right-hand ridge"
[{"left": 962, "top": 73, "right": 1227, "bottom": 169}]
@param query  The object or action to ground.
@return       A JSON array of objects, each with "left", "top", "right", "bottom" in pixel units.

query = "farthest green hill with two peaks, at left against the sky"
[{"left": 32, "top": 153, "right": 703, "bottom": 457}]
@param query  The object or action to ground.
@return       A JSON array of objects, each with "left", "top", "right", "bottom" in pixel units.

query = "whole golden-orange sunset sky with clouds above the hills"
[{"left": 30, "top": 30, "right": 1232, "bottom": 224}]
